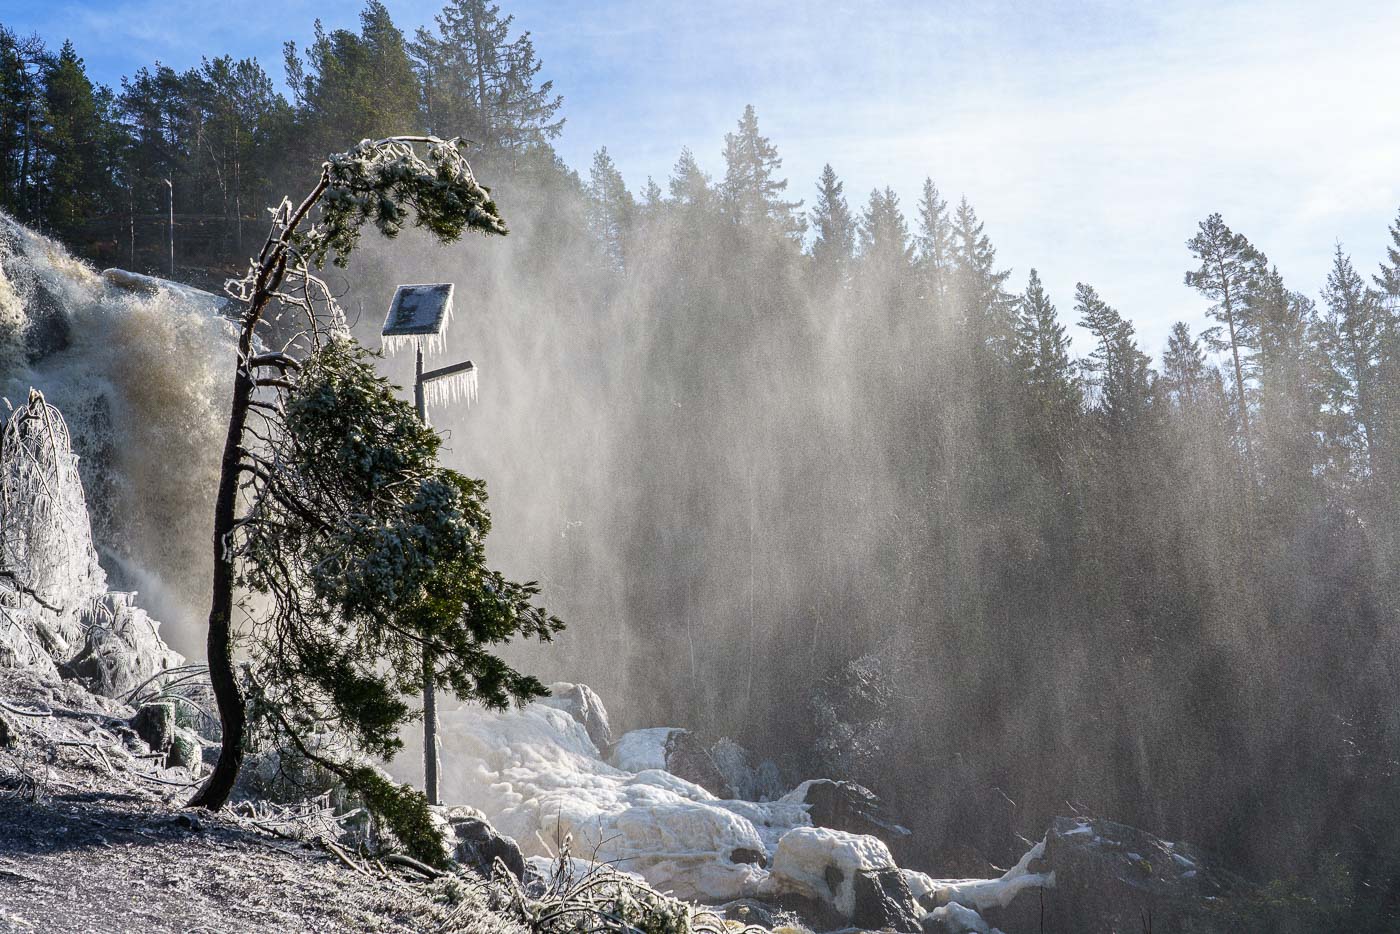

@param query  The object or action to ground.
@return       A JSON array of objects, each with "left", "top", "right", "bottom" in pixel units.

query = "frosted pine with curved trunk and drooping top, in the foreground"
[{"left": 190, "top": 137, "right": 563, "bottom": 861}]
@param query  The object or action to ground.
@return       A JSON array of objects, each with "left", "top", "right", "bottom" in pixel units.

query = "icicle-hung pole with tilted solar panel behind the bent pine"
[{"left": 381, "top": 283, "right": 476, "bottom": 804}]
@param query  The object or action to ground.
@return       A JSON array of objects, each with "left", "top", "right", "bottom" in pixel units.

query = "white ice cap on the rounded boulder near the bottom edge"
[{"left": 771, "top": 828, "right": 895, "bottom": 917}]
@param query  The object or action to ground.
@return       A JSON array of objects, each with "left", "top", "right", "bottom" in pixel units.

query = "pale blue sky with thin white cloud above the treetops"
[{"left": 0, "top": 0, "right": 1400, "bottom": 354}]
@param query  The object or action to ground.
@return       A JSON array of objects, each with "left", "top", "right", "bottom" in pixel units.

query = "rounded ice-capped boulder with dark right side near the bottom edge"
[{"left": 770, "top": 828, "right": 920, "bottom": 931}]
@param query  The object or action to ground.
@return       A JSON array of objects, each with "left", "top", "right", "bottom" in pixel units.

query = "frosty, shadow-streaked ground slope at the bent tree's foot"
[{"left": 0, "top": 669, "right": 524, "bottom": 934}]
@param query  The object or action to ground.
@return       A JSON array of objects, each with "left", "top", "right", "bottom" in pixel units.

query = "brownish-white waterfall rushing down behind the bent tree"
[{"left": 0, "top": 214, "right": 234, "bottom": 655}]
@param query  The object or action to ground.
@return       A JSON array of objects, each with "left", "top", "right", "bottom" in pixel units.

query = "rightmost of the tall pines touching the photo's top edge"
[{"left": 412, "top": 0, "right": 564, "bottom": 155}]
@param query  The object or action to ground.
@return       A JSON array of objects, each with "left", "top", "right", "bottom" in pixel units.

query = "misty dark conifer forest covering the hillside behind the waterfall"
[{"left": 8, "top": 0, "right": 1400, "bottom": 924}]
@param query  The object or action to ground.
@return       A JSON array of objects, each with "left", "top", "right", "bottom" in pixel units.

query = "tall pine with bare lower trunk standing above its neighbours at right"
[{"left": 1186, "top": 214, "right": 1266, "bottom": 463}]
